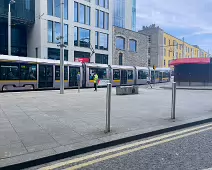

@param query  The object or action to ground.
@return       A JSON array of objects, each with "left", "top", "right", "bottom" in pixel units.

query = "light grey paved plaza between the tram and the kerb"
[{"left": 0, "top": 86, "right": 212, "bottom": 167}]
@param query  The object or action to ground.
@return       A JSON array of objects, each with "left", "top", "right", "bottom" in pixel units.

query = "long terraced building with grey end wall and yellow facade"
[{"left": 138, "top": 24, "right": 210, "bottom": 67}]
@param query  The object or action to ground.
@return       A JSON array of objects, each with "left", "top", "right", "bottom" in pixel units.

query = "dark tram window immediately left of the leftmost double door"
[{"left": 20, "top": 64, "right": 37, "bottom": 80}]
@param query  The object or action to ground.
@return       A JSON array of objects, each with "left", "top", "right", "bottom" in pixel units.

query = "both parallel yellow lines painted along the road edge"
[{"left": 40, "top": 123, "right": 212, "bottom": 170}]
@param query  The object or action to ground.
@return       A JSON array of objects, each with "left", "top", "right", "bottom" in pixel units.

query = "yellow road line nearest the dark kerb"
[{"left": 40, "top": 123, "right": 212, "bottom": 170}]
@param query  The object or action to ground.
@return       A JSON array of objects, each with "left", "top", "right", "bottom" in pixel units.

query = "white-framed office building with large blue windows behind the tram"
[{"left": 28, "top": 0, "right": 113, "bottom": 64}]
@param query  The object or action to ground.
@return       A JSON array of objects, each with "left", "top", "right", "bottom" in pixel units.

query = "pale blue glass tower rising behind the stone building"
[{"left": 113, "top": 0, "right": 136, "bottom": 31}]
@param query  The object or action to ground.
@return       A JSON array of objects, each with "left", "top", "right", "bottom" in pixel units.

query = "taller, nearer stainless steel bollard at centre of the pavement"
[{"left": 105, "top": 83, "right": 112, "bottom": 133}]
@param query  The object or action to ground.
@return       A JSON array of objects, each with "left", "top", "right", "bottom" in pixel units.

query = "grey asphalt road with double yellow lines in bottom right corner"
[{"left": 35, "top": 123, "right": 212, "bottom": 170}]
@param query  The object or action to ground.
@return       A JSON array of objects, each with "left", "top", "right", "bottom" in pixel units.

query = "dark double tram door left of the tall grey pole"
[{"left": 38, "top": 65, "right": 53, "bottom": 88}]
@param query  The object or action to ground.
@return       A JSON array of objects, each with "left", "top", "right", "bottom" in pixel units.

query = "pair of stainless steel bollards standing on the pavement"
[{"left": 105, "top": 82, "right": 176, "bottom": 133}]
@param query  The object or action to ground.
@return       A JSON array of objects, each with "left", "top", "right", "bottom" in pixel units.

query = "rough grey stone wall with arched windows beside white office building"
[{"left": 113, "top": 27, "right": 148, "bottom": 67}]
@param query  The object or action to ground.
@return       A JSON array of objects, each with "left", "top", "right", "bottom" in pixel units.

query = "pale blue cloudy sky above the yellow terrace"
[{"left": 136, "top": 0, "right": 212, "bottom": 53}]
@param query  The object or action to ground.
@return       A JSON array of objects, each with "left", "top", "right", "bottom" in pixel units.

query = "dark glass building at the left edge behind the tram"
[{"left": 0, "top": 0, "right": 35, "bottom": 56}]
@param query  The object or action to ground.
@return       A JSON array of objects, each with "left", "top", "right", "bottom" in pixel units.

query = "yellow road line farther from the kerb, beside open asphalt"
[{"left": 66, "top": 127, "right": 212, "bottom": 170}]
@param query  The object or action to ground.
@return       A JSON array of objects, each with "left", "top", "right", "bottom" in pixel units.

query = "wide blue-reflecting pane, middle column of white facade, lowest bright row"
[{"left": 79, "top": 28, "right": 90, "bottom": 48}]
